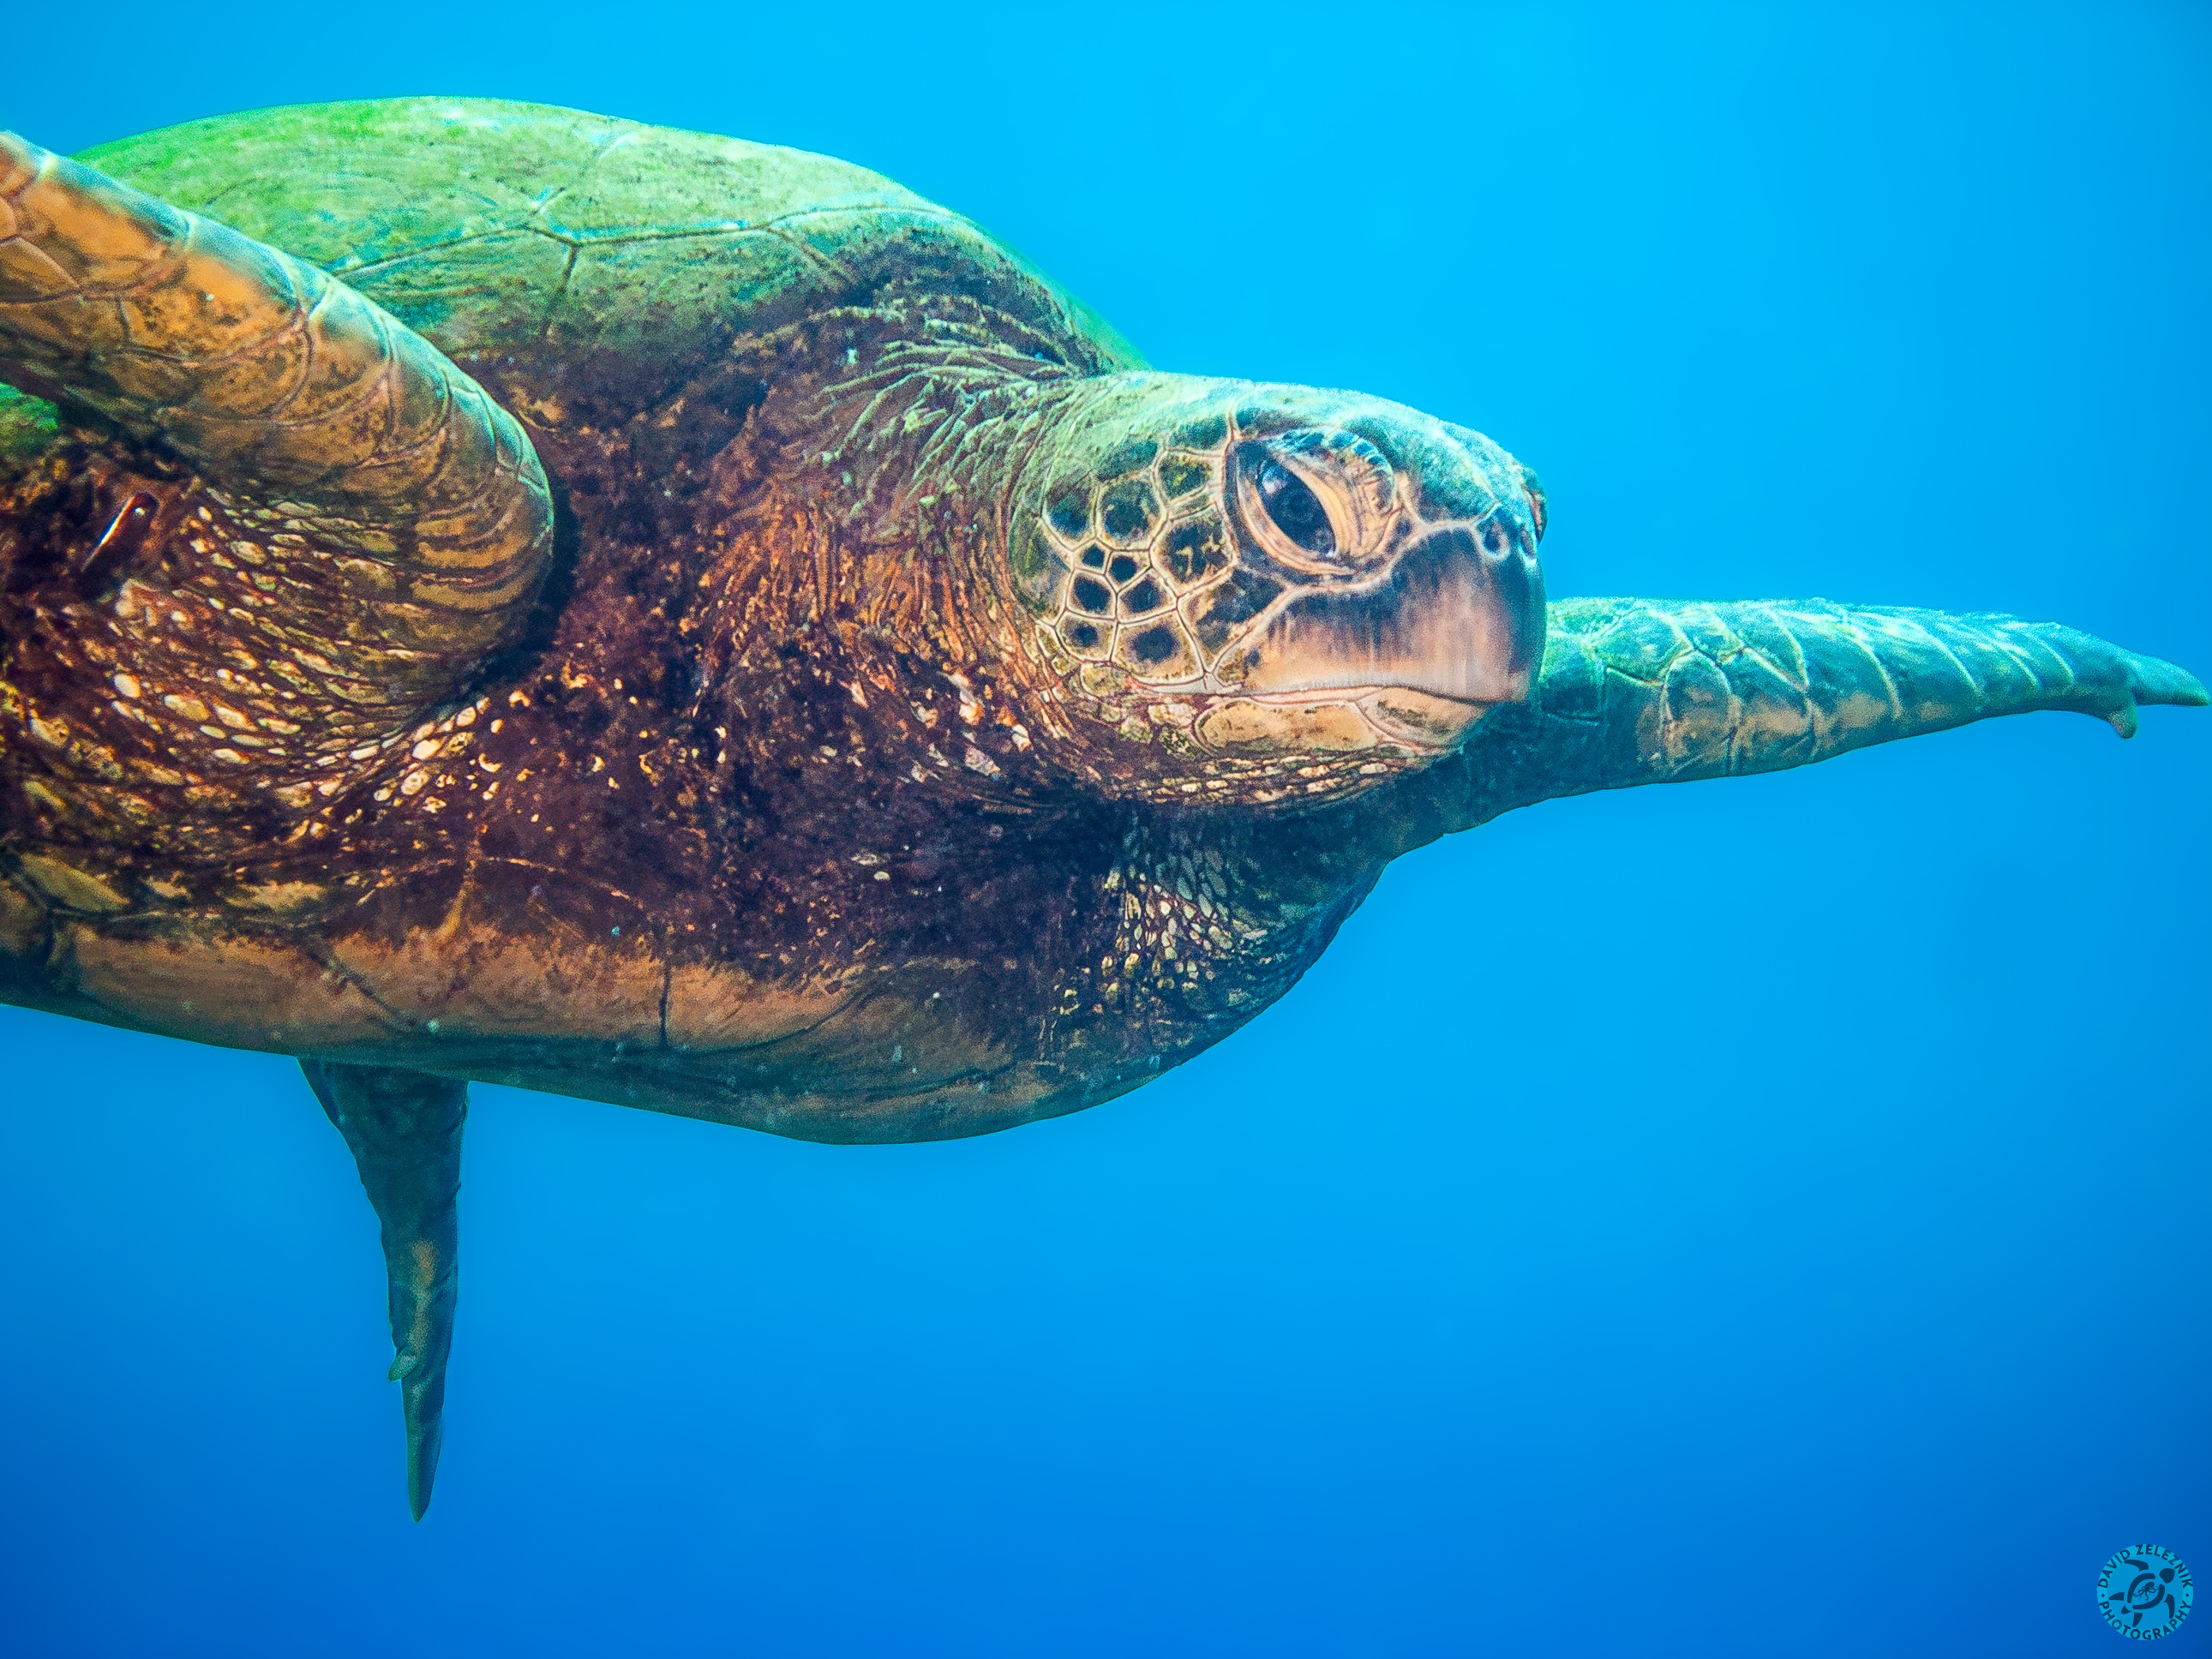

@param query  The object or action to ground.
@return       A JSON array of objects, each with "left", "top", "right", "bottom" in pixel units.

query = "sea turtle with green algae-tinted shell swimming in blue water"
[{"left": 0, "top": 99, "right": 2205, "bottom": 1515}]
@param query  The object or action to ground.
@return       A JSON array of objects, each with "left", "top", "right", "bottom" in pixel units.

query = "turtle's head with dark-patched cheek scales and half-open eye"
[{"left": 1006, "top": 374, "right": 1544, "bottom": 806}]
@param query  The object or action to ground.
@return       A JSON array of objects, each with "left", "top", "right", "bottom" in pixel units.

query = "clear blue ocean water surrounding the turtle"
[{"left": 0, "top": 0, "right": 2212, "bottom": 1659}]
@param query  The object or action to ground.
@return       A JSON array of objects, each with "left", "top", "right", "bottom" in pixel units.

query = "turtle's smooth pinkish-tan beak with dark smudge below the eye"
[{"left": 1244, "top": 513, "right": 1544, "bottom": 743}]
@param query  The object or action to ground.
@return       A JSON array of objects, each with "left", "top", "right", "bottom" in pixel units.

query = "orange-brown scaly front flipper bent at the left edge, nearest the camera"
[{"left": 0, "top": 133, "right": 553, "bottom": 710}]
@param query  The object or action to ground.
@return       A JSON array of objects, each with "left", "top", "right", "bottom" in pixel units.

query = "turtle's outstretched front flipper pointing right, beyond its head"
[{"left": 1429, "top": 600, "right": 2208, "bottom": 830}]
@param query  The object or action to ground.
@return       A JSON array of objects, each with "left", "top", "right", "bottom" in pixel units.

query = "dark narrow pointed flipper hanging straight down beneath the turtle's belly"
[{"left": 298, "top": 1059, "right": 469, "bottom": 1519}]
